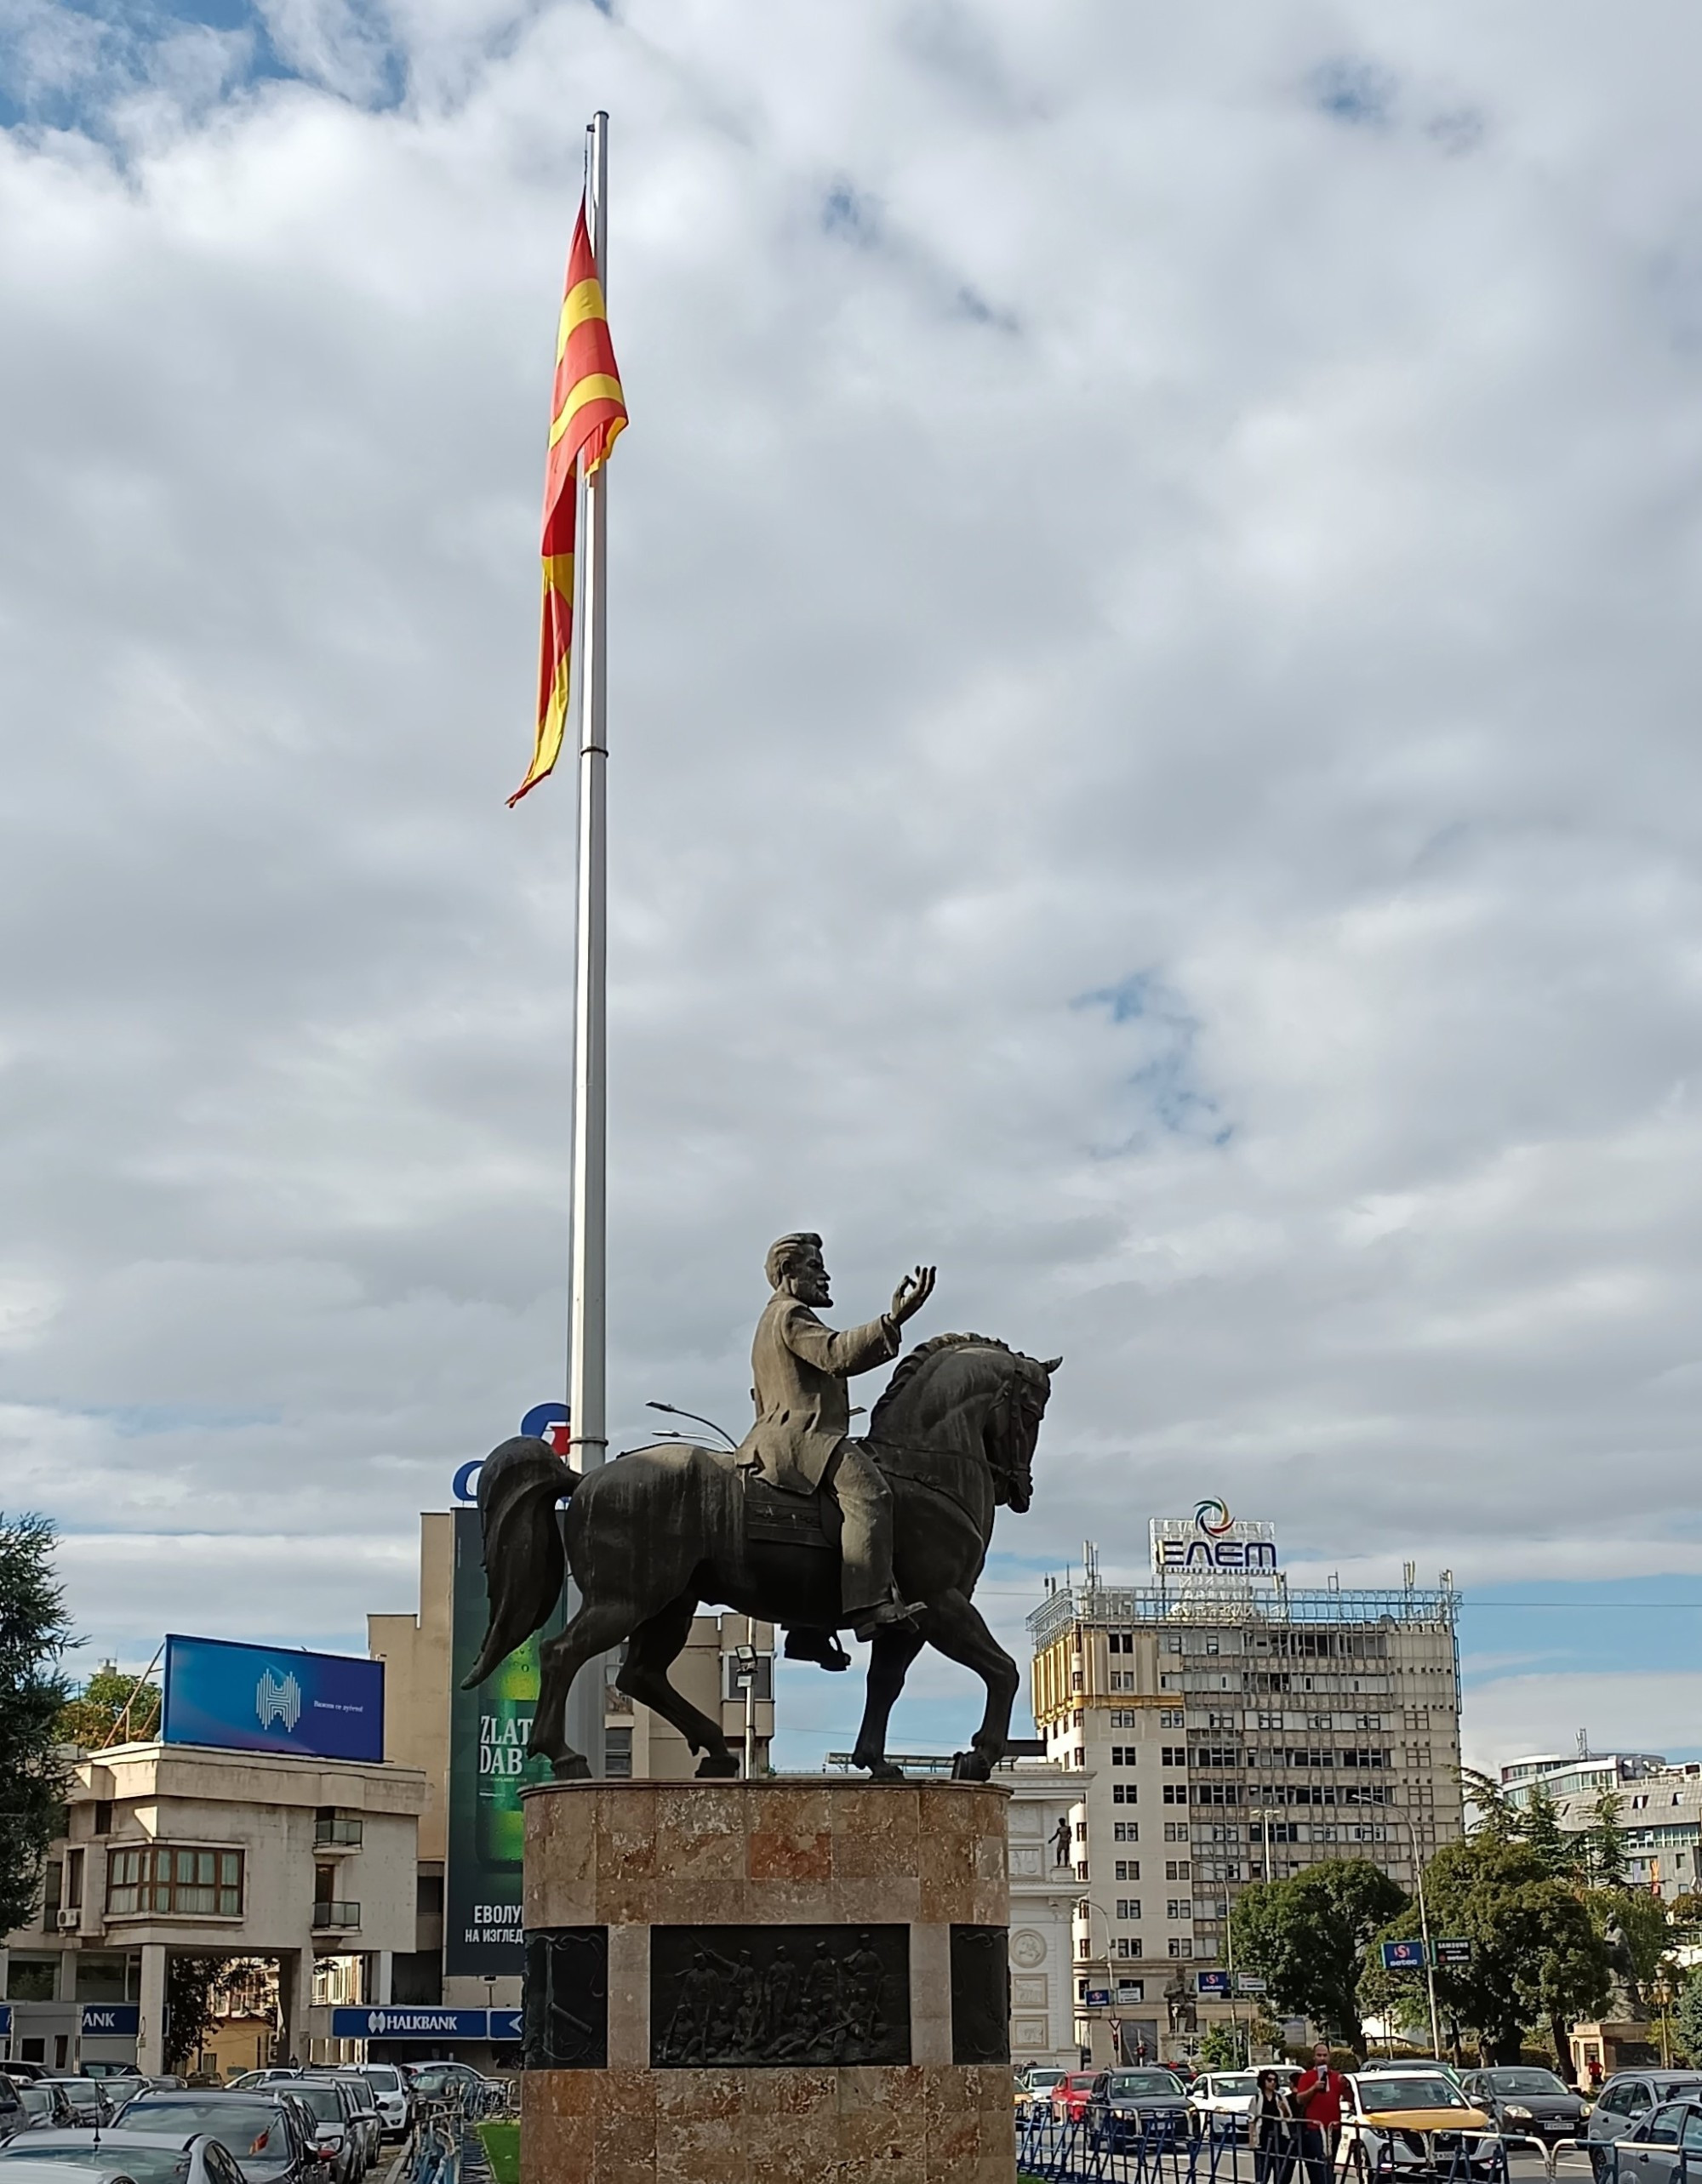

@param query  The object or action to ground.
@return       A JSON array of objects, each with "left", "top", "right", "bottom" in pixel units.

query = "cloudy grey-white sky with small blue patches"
[{"left": 0, "top": 0, "right": 1702, "bottom": 1765}]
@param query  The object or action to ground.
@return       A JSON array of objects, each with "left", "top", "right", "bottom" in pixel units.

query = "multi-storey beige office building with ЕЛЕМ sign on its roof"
[{"left": 1029, "top": 1554, "right": 1464, "bottom": 2061}]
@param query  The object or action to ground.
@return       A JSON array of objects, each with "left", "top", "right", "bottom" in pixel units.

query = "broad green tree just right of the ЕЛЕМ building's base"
[{"left": 1361, "top": 1833, "right": 1613, "bottom": 2068}]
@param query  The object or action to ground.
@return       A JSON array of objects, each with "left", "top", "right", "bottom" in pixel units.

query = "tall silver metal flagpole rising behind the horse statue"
[{"left": 568, "top": 111, "right": 609, "bottom": 1776}]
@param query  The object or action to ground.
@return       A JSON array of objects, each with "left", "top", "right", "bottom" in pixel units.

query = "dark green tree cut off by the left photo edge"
[{"left": 0, "top": 1514, "right": 70, "bottom": 1933}]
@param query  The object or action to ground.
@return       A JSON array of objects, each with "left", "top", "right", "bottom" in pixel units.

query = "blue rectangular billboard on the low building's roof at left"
[{"left": 159, "top": 1636, "right": 385, "bottom": 1760}]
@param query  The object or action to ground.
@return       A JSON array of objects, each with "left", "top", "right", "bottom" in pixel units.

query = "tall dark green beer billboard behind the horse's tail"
[{"left": 443, "top": 1509, "right": 563, "bottom": 1979}]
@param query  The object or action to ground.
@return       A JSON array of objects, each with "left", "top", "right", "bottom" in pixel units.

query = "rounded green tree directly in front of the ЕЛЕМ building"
[{"left": 1230, "top": 1859, "right": 1407, "bottom": 2056}]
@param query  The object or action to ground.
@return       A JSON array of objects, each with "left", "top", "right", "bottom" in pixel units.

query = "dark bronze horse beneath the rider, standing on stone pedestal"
[{"left": 465, "top": 1334, "right": 1062, "bottom": 1782}]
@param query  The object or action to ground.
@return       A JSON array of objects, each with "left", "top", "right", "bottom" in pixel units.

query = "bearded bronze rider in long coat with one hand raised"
[{"left": 739, "top": 1232, "right": 933, "bottom": 1638}]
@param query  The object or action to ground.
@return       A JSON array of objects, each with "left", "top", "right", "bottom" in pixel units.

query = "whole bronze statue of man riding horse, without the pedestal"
[{"left": 465, "top": 1232, "right": 1062, "bottom": 1782}]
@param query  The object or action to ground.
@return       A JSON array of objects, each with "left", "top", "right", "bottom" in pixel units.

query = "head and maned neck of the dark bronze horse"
[{"left": 870, "top": 1334, "right": 1064, "bottom": 1514}]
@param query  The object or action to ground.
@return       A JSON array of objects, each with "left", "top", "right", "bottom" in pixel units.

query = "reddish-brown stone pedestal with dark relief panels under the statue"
[{"left": 520, "top": 1776, "right": 1016, "bottom": 2184}]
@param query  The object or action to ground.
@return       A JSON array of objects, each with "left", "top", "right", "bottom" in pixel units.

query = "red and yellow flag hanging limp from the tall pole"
[{"left": 509, "top": 199, "right": 627, "bottom": 806}]
